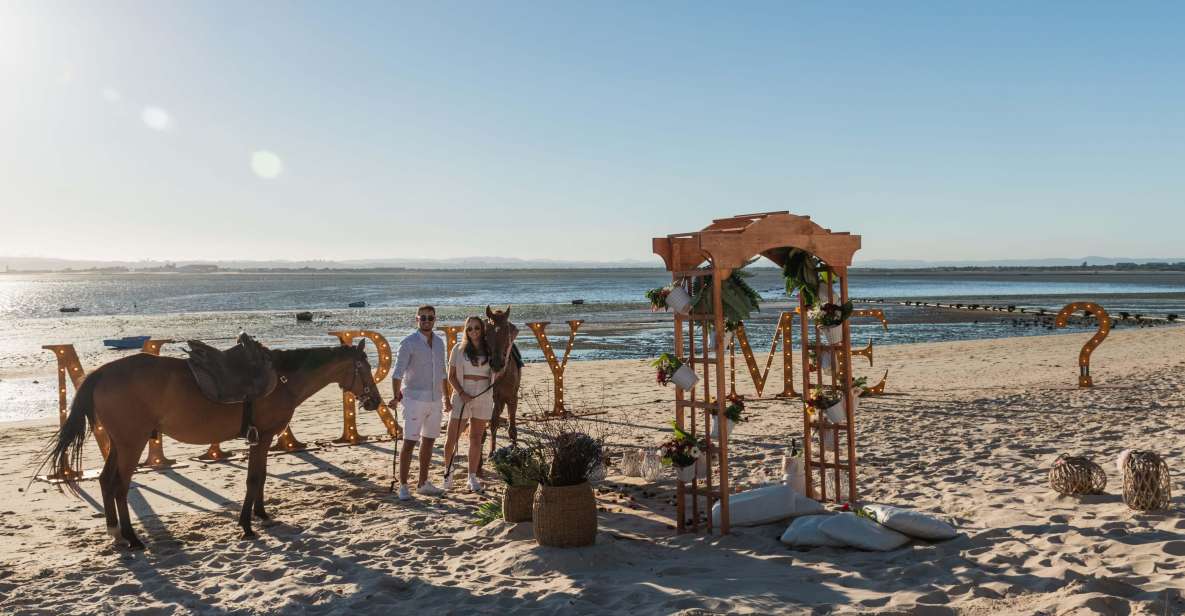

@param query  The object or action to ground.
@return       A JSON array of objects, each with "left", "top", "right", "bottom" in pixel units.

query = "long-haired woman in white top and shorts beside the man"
[{"left": 444, "top": 316, "right": 494, "bottom": 492}]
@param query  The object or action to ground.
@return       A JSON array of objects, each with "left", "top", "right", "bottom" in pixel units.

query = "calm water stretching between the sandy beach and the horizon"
[{"left": 0, "top": 269, "right": 1185, "bottom": 422}]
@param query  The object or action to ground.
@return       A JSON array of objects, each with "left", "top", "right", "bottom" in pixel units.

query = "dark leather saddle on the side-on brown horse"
[{"left": 187, "top": 334, "right": 280, "bottom": 404}]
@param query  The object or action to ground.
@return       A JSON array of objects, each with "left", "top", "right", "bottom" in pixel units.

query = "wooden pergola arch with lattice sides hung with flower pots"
[{"left": 653, "top": 211, "right": 860, "bottom": 533}]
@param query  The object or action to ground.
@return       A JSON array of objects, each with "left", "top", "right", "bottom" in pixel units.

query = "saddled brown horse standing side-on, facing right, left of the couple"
[{"left": 41, "top": 340, "right": 382, "bottom": 550}]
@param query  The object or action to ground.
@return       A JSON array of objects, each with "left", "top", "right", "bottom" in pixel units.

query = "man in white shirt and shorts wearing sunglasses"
[{"left": 391, "top": 306, "right": 453, "bottom": 500}]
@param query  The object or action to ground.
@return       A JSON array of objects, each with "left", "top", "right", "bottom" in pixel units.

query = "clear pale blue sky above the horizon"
[{"left": 0, "top": 0, "right": 1185, "bottom": 262}]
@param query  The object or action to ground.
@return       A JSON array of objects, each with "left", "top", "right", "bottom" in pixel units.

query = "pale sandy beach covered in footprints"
[{"left": 0, "top": 327, "right": 1185, "bottom": 615}]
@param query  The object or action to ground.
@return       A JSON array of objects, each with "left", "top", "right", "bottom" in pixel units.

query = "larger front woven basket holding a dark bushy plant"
[{"left": 532, "top": 482, "right": 596, "bottom": 547}]
